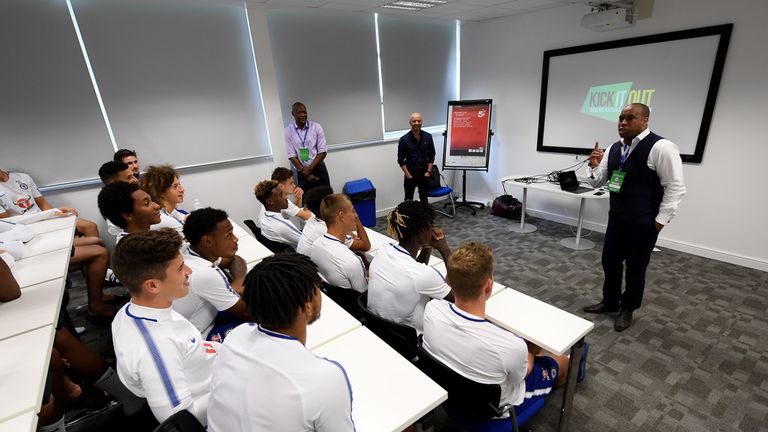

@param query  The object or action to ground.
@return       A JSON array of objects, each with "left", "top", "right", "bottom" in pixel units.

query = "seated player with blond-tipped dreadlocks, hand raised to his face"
[{"left": 368, "top": 201, "right": 453, "bottom": 333}]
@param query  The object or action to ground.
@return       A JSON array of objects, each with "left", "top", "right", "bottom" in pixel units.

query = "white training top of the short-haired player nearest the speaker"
[{"left": 424, "top": 300, "right": 528, "bottom": 405}]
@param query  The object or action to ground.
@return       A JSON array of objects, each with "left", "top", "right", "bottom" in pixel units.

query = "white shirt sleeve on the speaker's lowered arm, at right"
[{"left": 648, "top": 139, "right": 685, "bottom": 225}]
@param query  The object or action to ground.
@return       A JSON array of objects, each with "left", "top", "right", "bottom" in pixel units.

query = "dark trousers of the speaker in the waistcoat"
[{"left": 602, "top": 217, "right": 659, "bottom": 311}]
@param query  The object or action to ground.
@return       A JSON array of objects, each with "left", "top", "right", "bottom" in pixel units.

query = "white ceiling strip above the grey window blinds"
[{"left": 246, "top": 0, "right": 586, "bottom": 21}]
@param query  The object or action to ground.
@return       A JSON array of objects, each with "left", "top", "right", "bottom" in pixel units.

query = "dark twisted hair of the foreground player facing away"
[{"left": 243, "top": 252, "right": 321, "bottom": 329}]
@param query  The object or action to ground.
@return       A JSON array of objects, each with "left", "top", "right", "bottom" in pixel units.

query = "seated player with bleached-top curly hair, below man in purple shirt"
[{"left": 255, "top": 180, "right": 310, "bottom": 249}]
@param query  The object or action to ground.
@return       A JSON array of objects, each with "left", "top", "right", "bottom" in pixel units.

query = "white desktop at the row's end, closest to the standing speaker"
[{"left": 485, "top": 289, "right": 595, "bottom": 355}]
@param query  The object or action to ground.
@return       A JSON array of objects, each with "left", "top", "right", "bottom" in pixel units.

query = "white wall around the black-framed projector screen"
[{"left": 461, "top": 0, "right": 768, "bottom": 271}]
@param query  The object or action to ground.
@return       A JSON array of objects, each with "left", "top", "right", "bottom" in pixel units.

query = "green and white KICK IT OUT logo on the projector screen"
[{"left": 581, "top": 81, "right": 656, "bottom": 123}]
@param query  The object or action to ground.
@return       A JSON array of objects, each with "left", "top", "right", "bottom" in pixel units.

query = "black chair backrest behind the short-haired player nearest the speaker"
[{"left": 417, "top": 347, "right": 510, "bottom": 420}]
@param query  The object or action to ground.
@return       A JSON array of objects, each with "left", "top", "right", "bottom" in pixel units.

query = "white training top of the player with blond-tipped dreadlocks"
[{"left": 368, "top": 244, "right": 451, "bottom": 333}]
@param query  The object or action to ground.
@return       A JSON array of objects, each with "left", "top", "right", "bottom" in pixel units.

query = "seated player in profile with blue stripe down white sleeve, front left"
[{"left": 112, "top": 228, "right": 219, "bottom": 425}]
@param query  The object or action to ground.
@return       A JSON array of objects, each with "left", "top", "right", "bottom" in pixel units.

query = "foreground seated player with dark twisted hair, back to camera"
[{"left": 208, "top": 253, "right": 354, "bottom": 432}]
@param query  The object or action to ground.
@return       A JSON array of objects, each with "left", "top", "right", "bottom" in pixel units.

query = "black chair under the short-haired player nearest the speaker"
[{"left": 416, "top": 336, "right": 543, "bottom": 432}]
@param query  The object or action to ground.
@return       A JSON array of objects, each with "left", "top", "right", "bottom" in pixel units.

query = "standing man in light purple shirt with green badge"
[{"left": 284, "top": 102, "right": 331, "bottom": 192}]
